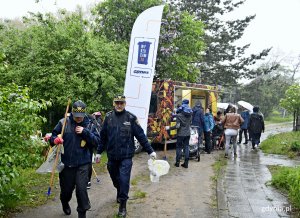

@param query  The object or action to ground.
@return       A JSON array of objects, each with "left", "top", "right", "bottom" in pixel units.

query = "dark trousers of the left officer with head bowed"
[{"left": 59, "top": 164, "right": 91, "bottom": 212}]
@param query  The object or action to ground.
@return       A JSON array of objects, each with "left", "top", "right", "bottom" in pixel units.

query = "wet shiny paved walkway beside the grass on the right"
[{"left": 217, "top": 125, "right": 300, "bottom": 218}]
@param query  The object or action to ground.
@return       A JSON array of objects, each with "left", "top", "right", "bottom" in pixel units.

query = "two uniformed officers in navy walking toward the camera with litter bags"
[{"left": 49, "top": 95, "right": 156, "bottom": 218}]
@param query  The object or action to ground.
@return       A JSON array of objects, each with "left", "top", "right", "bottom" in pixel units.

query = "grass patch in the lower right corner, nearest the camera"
[{"left": 269, "top": 166, "right": 300, "bottom": 217}]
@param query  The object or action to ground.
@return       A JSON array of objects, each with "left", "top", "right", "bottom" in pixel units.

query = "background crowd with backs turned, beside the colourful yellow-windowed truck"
[{"left": 167, "top": 99, "right": 265, "bottom": 168}]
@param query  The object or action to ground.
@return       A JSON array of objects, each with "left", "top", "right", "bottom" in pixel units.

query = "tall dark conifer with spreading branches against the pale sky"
[{"left": 169, "top": 0, "right": 270, "bottom": 85}]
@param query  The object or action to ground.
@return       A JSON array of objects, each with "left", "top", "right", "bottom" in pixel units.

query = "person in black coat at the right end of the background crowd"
[{"left": 249, "top": 106, "right": 265, "bottom": 149}]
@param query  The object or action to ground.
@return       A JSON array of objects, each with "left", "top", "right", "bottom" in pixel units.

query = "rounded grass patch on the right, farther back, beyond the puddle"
[{"left": 260, "top": 131, "right": 300, "bottom": 158}]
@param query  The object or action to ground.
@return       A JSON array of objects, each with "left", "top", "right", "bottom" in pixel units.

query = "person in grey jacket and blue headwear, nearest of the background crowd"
[{"left": 168, "top": 99, "right": 193, "bottom": 168}]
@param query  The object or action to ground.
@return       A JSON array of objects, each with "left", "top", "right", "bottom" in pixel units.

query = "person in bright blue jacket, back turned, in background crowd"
[{"left": 204, "top": 108, "right": 215, "bottom": 154}]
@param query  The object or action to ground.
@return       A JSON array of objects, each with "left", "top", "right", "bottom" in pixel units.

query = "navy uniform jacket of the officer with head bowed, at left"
[{"left": 50, "top": 114, "right": 100, "bottom": 167}]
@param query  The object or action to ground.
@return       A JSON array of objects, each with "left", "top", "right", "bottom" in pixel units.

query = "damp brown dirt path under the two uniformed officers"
[{"left": 14, "top": 149, "right": 219, "bottom": 218}]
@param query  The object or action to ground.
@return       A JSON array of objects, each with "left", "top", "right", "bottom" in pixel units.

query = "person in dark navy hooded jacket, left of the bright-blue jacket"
[{"left": 192, "top": 101, "right": 204, "bottom": 148}]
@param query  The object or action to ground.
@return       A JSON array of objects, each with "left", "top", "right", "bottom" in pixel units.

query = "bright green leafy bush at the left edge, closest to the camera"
[{"left": 0, "top": 84, "right": 50, "bottom": 215}]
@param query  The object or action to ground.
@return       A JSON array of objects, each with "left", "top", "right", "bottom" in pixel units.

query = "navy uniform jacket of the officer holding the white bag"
[{"left": 97, "top": 110, "right": 153, "bottom": 160}]
